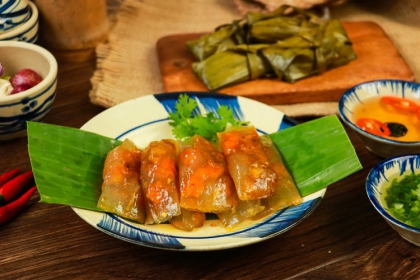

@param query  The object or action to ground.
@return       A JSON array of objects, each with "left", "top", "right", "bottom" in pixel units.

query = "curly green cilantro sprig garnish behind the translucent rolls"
[{"left": 169, "top": 94, "right": 248, "bottom": 142}]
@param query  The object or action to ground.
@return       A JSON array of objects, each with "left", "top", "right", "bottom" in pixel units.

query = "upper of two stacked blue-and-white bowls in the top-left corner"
[{"left": 0, "top": 0, "right": 31, "bottom": 33}]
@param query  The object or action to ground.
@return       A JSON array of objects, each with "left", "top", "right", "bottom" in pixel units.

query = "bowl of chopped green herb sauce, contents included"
[{"left": 366, "top": 154, "right": 420, "bottom": 246}]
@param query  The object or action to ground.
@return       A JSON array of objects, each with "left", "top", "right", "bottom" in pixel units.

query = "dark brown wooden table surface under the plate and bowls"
[{"left": 0, "top": 25, "right": 420, "bottom": 280}]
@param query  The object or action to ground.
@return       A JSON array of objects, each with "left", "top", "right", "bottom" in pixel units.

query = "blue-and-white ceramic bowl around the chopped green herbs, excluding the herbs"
[{"left": 366, "top": 154, "right": 420, "bottom": 246}]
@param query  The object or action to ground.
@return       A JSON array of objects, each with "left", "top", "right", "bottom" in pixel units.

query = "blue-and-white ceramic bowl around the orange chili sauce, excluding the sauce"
[{"left": 338, "top": 80, "right": 420, "bottom": 158}]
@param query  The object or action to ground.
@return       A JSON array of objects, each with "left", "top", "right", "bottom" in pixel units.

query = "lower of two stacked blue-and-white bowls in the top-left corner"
[{"left": 0, "top": 1, "right": 39, "bottom": 43}]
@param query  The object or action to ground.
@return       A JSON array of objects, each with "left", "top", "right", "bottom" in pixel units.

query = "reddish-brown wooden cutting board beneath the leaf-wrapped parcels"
[{"left": 156, "top": 22, "right": 414, "bottom": 105}]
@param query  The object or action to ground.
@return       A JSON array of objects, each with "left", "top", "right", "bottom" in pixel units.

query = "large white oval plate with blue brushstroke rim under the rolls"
[{"left": 73, "top": 92, "right": 326, "bottom": 251}]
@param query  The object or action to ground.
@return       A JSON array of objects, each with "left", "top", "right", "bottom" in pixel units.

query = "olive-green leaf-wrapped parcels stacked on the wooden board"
[{"left": 187, "top": 5, "right": 356, "bottom": 90}]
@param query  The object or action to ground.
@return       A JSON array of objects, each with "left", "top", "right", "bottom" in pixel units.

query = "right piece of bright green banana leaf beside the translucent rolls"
[{"left": 270, "top": 115, "right": 361, "bottom": 196}]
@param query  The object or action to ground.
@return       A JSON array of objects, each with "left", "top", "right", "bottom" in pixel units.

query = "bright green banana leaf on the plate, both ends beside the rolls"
[{"left": 27, "top": 115, "right": 361, "bottom": 211}]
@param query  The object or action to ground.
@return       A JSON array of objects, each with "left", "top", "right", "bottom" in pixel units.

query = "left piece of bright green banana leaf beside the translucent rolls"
[{"left": 28, "top": 122, "right": 122, "bottom": 210}]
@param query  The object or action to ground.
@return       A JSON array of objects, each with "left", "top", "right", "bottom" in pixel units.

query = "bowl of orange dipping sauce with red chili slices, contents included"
[{"left": 338, "top": 80, "right": 420, "bottom": 158}]
